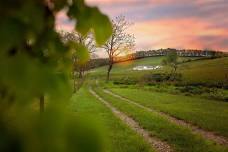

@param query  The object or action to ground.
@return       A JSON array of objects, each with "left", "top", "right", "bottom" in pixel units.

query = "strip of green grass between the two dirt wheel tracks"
[{"left": 96, "top": 89, "right": 227, "bottom": 152}]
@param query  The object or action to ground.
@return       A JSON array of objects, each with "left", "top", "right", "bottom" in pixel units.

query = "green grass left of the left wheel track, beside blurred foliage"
[{"left": 70, "top": 88, "right": 153, "bottom": 152}]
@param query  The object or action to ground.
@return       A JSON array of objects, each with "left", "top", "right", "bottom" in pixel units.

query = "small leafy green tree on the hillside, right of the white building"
[{"left": 162, "top": 51, "right": 178, "bottom": 78}]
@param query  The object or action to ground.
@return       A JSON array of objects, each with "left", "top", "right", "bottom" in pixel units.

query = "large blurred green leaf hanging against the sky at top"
[{"left": 68, "top": 0, "right": 112, "bottom": 45}]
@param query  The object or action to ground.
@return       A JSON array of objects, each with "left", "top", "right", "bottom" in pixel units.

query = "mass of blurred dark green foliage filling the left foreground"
[{"left": 0, "top": 0, "right": 112, "bottom": 152}]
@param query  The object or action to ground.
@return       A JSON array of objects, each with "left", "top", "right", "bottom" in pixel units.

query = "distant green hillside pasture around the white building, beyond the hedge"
[{"left": 92, "top": 57, "right": 228, "bottom": 84}]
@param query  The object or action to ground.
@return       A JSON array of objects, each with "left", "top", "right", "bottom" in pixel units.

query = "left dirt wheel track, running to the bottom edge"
[{"left": 89, "top": 89, "right": 172, "bottom": 152}]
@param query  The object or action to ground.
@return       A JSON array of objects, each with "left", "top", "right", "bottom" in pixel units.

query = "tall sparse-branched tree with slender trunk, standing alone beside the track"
[{"left": 102, "top": 16, "right": 135, "bottom": 81}]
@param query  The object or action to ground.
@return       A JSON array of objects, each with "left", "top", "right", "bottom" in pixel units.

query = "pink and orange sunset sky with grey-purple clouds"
[{"left": 57, "top": 0, "right": 228, "bottom": 51}]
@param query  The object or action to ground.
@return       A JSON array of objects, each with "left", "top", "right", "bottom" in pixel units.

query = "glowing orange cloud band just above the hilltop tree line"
[{"left": 129, "top": 18, "right": 228, "bottom": 50}]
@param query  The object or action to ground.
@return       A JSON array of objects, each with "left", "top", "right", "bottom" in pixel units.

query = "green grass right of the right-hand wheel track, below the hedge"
[{"left": 111, "top": 88, "right": 228, "bottom": 137}]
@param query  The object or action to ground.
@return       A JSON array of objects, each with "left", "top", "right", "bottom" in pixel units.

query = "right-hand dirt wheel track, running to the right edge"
[{"left": 103, "top": 89, "right": 228, "bottom": 146}]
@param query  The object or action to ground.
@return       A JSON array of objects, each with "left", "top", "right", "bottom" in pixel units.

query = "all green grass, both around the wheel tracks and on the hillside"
[{"left": 71, "top": 57, "right": 228, "bottom": 152}]
